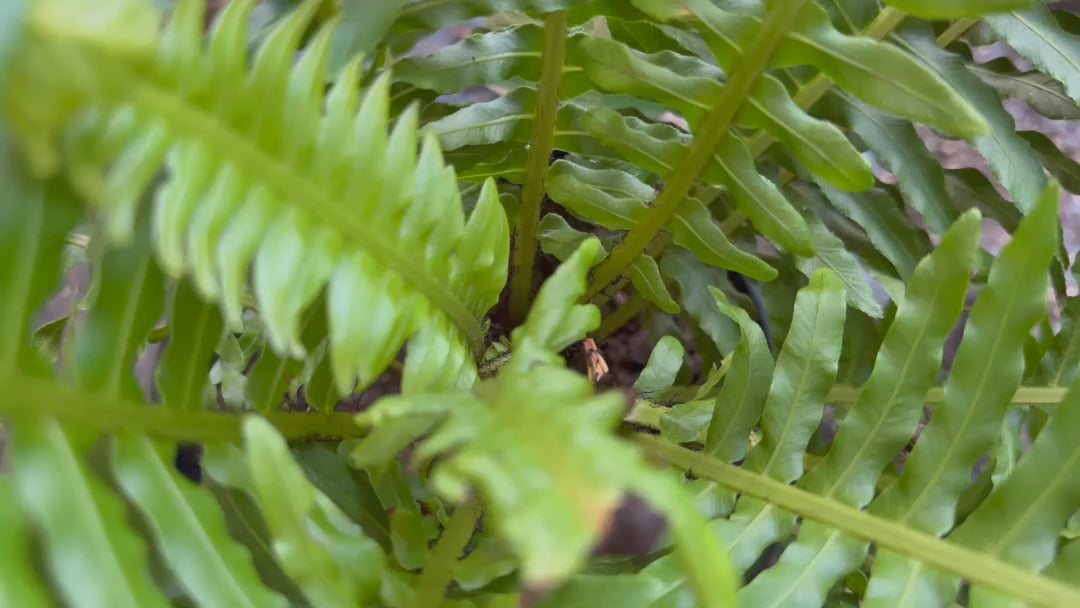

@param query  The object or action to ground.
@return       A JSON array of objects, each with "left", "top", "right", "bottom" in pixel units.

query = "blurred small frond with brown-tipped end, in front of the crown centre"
[{"left": 357, "top": 240, "right": 733, "bottom": 606}]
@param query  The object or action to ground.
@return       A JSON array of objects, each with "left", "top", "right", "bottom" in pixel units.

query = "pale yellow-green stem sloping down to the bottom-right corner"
[{"left": 636, "top": 434, "right": 1080, "bottom": 608}]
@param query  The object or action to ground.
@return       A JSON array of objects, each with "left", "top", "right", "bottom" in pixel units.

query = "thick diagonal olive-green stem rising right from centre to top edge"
[{"left": 585, "top": 0, "right": 808, "bottom": 300}]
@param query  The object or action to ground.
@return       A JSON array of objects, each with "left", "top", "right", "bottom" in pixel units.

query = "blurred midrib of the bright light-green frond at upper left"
[{"left": 126, "top": 82, "right": 484, "bottom": 347}]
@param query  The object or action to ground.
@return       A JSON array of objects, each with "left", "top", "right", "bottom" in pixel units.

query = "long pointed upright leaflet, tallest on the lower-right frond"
[{"left": 867, "top": 186, "right": 1058, "bottom": 595}]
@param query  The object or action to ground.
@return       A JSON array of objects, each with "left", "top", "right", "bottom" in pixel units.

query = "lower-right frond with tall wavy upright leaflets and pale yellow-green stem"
[{"left": 559, "top": 185, "right": 1080, "bottom": 607}]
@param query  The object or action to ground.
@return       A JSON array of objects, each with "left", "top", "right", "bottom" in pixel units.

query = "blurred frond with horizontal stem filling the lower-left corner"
[{"left": 0, "top": 146, "right": 386, "bottom": 607}]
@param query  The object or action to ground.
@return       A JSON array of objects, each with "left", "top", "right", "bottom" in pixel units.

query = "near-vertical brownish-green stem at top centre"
[{"left": 510, "top": 11, "right": 566, "bottom": 324}]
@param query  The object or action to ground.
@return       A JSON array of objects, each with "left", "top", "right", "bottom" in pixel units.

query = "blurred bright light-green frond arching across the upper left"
[{"left": 2, "top": 0, "right": 510, "bottom": 391}]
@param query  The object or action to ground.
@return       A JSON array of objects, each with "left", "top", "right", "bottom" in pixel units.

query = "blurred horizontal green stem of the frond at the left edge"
[{"left": 0, "top": 373, "right": 366, "bottom": 443}]
